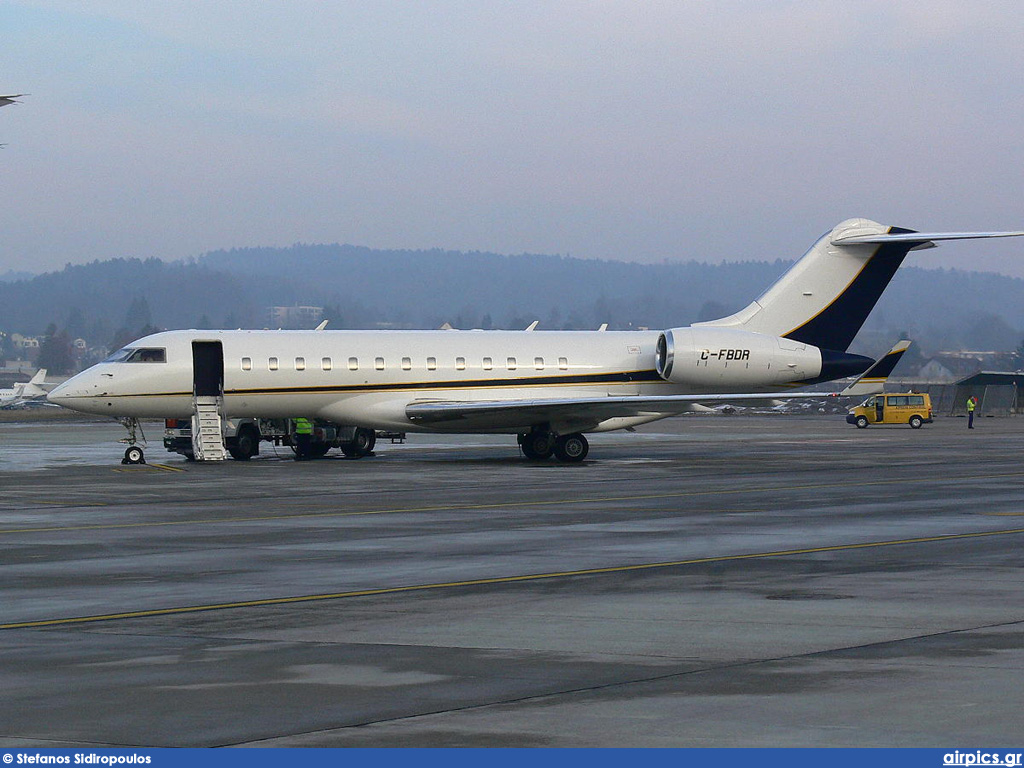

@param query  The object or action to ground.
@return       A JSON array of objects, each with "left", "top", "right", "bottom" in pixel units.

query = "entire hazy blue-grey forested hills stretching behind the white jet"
[{"left": 0, "top": 245, "right": 1024, "bottom": 351}]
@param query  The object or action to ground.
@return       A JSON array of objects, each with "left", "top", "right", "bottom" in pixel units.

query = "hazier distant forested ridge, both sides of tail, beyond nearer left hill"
[{"left": 198, "top": 245, "right": 1024, "bottom": 349}]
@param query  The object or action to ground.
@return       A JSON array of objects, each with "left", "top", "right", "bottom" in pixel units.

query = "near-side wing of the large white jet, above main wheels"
[{"left": 406, "top": 392, "right": 839, "bottom": 430}]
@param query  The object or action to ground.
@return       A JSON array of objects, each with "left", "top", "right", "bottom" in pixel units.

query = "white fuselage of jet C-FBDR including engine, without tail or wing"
[{"left": 50, "top": 328, "right": 831, "bottom": 433}]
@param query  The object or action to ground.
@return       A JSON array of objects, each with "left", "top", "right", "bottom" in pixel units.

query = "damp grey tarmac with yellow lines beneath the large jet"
[{"left": 0, "top": 415, "right": 1024, "bottom": 748}]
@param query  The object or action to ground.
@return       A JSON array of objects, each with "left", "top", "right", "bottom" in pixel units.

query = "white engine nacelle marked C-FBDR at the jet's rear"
[{"left": 654, "top": 327, "right": 821, "bottom": 392}]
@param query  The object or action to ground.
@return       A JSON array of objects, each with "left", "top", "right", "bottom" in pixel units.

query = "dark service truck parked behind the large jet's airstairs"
[{"left": 164, "top": 419, "right": 387, "bottom": 461}]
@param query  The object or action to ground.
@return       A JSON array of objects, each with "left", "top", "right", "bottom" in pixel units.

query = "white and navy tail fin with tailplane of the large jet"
[{"left": 694, "top": 219, "right": 1024, "bottom": 352}]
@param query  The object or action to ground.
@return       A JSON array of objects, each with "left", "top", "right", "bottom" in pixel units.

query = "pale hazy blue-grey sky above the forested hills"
[{"left": 0, "top": 0, "right": 1024, "bottom": 276}]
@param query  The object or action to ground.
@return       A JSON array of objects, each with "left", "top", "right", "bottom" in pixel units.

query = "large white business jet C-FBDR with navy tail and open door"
[{"left": 49, "top": 219, "right": 1024, "bottom": 462}]
